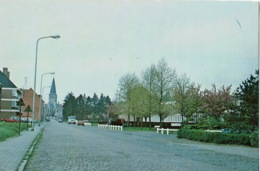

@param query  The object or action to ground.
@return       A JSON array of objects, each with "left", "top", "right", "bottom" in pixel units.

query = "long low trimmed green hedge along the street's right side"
[{"left": 177, "top": 129, "right": 250, "bottom": 145}]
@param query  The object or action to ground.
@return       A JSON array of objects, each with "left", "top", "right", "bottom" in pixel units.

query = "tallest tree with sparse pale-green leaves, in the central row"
[{"left": 155, "top": 59, "right": 176, "bottom": 124}]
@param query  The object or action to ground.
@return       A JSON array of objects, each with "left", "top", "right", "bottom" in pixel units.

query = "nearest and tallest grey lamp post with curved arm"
[{"left": 32, "top": 35, "right": 60, "bottom": 131}]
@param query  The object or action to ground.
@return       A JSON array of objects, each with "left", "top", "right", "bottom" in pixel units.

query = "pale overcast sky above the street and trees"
[{"left": 0, "top": 0, "right": 259, "bottom": 103}]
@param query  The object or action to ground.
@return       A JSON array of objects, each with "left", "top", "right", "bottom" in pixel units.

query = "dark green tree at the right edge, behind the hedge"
[{"left": 225, "top": 70, "right": 259, "bottom": 132}]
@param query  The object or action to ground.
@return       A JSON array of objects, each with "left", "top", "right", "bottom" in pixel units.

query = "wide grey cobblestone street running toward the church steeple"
[{"left": 26, "top": 120, "right": 258, "bottom": 171}]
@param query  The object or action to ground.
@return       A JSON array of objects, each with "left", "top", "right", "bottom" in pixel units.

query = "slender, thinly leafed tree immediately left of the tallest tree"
[{"left": 142, "top": 65, "right": 156, "bottom": 129}]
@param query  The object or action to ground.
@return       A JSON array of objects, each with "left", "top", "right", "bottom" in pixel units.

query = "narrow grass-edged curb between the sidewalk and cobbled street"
[{"left": 16, "top": 126, "right": 45, "bottom": 171}]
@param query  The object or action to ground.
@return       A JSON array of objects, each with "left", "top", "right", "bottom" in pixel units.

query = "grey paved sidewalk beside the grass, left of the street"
[{"left": 0, "top": 124, "right": 44, "bottom": 171}]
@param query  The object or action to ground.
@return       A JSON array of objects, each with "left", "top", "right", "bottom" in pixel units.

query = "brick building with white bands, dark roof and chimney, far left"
[{"left": 0, "top": 68, "right": 23, "bottom": 119}]
